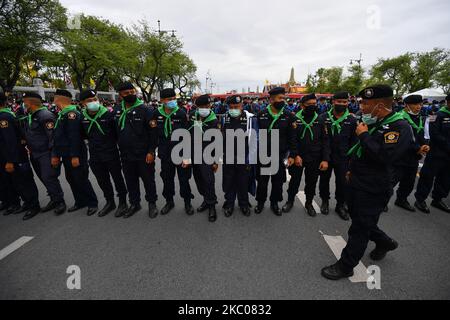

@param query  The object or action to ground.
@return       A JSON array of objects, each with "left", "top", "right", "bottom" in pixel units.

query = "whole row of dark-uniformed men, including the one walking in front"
[{"left": 0, "top": 82, "right": 450, "bottom": 279}]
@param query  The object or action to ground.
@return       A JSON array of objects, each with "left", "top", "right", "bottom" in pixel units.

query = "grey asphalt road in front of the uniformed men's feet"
[{"left": 0, "top": 162, "right": 450, "bottom": 299}]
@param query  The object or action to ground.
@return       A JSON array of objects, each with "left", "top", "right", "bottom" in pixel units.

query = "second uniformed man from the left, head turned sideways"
[{"left": 21, "top": 92, "right": 66, "bottom": 215}]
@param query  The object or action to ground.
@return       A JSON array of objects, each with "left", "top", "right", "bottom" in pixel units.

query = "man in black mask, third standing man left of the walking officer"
[{"left": 255, "top": 87, "right": 299, "bottom": 216}]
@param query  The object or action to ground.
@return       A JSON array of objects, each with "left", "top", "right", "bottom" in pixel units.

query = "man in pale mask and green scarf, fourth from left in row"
[{"left": 80, "top": 89, "right": 128, "bottom": 217}]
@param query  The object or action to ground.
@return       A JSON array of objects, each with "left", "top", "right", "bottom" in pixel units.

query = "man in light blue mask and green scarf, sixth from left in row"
[{"left": 150, "top": 88, "right": 194, "bottom": 215}]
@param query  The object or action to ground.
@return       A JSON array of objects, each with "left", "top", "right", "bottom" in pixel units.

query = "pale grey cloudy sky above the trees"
[{"left": 61, "top": 0, "right": 450, "bottom": 93}]
